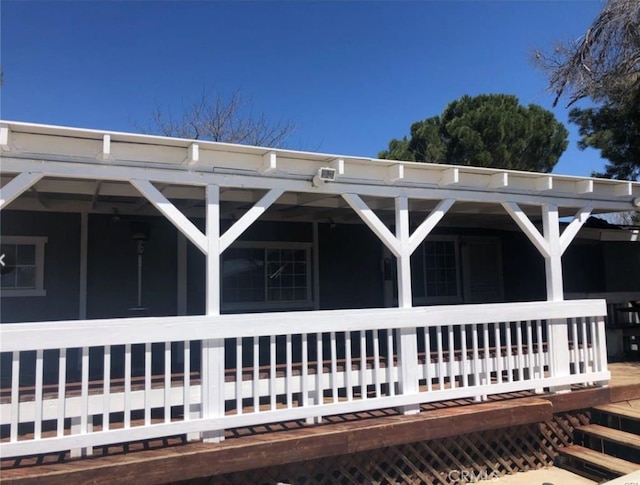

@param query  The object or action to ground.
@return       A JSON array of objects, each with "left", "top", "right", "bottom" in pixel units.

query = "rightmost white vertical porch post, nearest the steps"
[{"left": 542, "top": 204, "right": 570, "bottom": 392}]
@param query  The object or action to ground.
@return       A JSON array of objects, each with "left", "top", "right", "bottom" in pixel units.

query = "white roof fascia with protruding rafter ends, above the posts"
[{"left": 0, "top": 121, "right": 640, "bottom": 212}]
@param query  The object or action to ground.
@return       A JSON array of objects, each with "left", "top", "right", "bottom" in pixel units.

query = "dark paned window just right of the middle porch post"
[{"left": 413, "top": 236, "right": 462, "bottom": 303}]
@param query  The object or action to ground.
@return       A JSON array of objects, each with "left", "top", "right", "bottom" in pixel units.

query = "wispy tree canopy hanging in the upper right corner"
[{"left": 536, "top": 0, "right": 640, "bottom": 180}]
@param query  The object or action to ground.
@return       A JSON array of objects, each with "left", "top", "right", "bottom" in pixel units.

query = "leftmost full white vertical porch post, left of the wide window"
[{"left": 202, "top": 185, "right": 225, "bottom": 443}]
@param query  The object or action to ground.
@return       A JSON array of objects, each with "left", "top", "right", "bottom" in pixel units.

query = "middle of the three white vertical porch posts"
[{"left": 395, "top": 196, "right": 420, "bottom": 414}]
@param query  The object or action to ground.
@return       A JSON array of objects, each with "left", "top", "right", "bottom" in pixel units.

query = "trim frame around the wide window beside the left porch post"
[{"left": 220, "top": 241, "right": 313, "bottom": 311}]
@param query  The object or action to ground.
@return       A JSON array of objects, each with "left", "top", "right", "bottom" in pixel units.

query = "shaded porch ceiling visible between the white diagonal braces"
[{"left": 1, "top": 175, "right": 575, "bottom": 227}]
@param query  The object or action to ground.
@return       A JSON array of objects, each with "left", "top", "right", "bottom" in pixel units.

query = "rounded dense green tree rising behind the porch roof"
[{"left": 378, "top": 94, "right": 568, "bottom": 172}]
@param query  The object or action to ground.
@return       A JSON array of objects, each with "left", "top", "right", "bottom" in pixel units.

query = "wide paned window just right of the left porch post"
[{"left": 222, "top": 242, "right": 311, "bottom": 309}]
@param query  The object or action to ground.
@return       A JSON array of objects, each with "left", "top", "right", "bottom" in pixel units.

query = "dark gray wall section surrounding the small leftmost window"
[{"left": 0, "top": 210, "right": 80, "bottom": 323}]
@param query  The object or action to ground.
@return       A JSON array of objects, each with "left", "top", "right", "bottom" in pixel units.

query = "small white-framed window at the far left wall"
[{"left": 0, "top": 236, "right": 47, "bottom": 296}]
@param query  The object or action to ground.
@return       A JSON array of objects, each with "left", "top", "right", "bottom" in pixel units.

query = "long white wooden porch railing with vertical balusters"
[{"left": 0, "top": 300, "right": 609, "bottom": 457}]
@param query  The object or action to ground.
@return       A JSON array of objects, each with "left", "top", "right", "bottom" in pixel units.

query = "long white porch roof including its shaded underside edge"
[{"left": 0, "top": 121, "right": 640, "bottom": 217}]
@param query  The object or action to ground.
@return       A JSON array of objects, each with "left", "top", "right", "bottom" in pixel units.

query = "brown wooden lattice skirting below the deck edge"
[{"left": 180, "top": 410, "right": 590, "bottom": 485}]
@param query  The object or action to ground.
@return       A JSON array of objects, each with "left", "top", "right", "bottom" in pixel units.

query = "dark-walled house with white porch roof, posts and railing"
[{"left": 0, "top": 121, "right": 640, "bottom": 472}]
